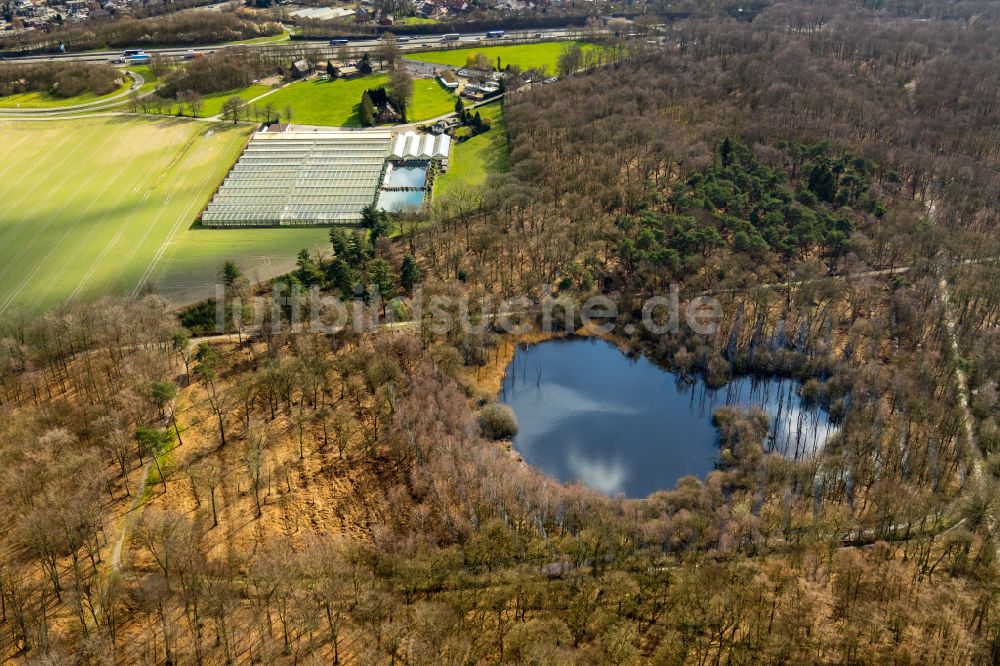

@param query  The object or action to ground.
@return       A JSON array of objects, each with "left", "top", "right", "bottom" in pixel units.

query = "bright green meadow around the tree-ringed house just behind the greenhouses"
[{"left": 262, "top": 74, "right": 455, "bottom": 127}]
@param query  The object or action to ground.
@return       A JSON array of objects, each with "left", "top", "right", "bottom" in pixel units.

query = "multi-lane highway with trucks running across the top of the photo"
[{"left": 2, "top": 28, "right": 593, "bottom": 63}]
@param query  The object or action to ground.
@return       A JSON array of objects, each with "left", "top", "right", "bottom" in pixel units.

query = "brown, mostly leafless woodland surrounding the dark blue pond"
[{"left": 0, "top": 2, "right": 1000, "bottom": 664}]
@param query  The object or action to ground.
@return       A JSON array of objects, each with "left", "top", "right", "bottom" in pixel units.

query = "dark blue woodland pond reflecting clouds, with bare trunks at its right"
[{"left": 499, "top": 338, "right": 836, "bottom": 497}]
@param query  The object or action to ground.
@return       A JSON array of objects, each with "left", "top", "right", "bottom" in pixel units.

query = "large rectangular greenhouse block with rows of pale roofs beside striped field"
[{"left": 201, "top": 131, "right": 392, "bottom": 227}]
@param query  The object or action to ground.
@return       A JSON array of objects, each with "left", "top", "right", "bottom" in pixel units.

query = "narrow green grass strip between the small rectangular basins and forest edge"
[{"left": 434, "top": 102, "right": 507, "bottom": 197}]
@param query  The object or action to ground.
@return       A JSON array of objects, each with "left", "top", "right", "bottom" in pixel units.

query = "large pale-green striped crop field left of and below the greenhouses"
[{"left": 0, "top": 118, "right": 327, "bottom": 315}]
